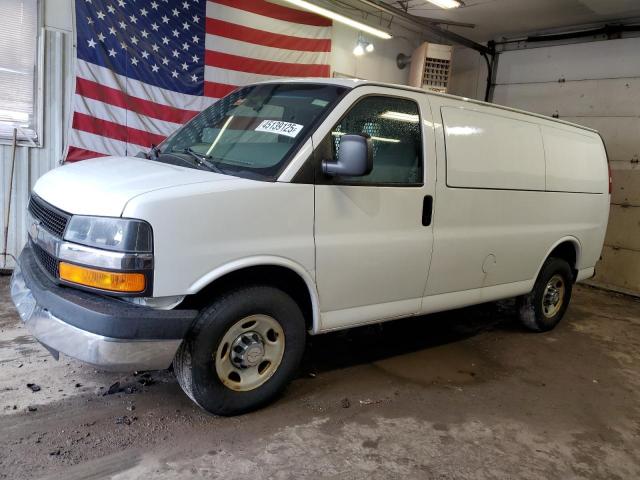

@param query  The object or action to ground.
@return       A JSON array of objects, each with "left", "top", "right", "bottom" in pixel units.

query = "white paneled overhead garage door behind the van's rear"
[{"left": 493, "top": 38, "right": 640, "bottom": 293}]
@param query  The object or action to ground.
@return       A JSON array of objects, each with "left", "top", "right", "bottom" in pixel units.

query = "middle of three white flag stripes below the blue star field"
[{"left": 75, "top": 94, "right": 182, "bottom": 137}]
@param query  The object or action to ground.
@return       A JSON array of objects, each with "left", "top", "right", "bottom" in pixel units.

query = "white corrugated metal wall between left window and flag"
[{"left": 0, "top": 30, "right": 73, "bottom": 268}]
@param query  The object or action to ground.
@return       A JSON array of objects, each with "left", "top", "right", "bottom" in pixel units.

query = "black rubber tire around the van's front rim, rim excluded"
[{"left": 173, "top": 285, "right": 306, "bottom": 416}]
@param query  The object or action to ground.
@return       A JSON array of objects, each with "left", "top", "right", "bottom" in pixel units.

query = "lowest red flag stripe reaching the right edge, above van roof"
[{"left": 204, "top": 50, "right": 330, "bottom": 77}]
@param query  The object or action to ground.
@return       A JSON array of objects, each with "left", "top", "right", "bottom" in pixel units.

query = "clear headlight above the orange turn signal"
[{"left": 64, "top": 215, "right": 153, "bottom": 253}]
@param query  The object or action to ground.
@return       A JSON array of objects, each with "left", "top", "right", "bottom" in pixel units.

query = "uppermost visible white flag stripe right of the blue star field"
[{"left": 207, "top": 2, "right": 331, "bottom": 39}]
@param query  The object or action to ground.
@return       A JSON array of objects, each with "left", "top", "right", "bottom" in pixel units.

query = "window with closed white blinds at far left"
[{"left": 0, "top": 0, "right": 38, "bottom": 141}]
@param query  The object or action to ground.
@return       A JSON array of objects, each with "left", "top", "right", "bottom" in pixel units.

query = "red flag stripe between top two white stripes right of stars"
[{"left": 207, "top": 18, "right": 331, "bottom": 52}]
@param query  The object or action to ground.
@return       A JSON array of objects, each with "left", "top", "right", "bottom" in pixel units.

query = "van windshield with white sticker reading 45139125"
[{"left": 157, "top": 83, "right": 345, "bottom": 181}]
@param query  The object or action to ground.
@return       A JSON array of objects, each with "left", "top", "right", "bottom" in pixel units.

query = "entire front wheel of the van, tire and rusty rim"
[{"left": 174, "top": 286, "right": 306, "bottom": 415}]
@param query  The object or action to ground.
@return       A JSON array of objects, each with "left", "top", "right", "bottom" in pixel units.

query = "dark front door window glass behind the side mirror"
[{"left": 325, "top": 96, "right": 423, "bottom": 186}]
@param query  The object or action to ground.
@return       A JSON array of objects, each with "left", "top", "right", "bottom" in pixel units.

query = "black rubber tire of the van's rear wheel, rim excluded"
[{"left": 517, "top": 257, "right": 574, "bottom": 332}]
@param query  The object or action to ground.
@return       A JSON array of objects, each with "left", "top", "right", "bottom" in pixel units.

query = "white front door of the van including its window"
[{"left": 313, "top": 86, "right": 435, "bottom": 330}]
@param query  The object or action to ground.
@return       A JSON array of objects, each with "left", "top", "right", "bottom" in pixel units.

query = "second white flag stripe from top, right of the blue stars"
[{"left": 205, "top": 34, "right": 330, "bottom": 65}]
